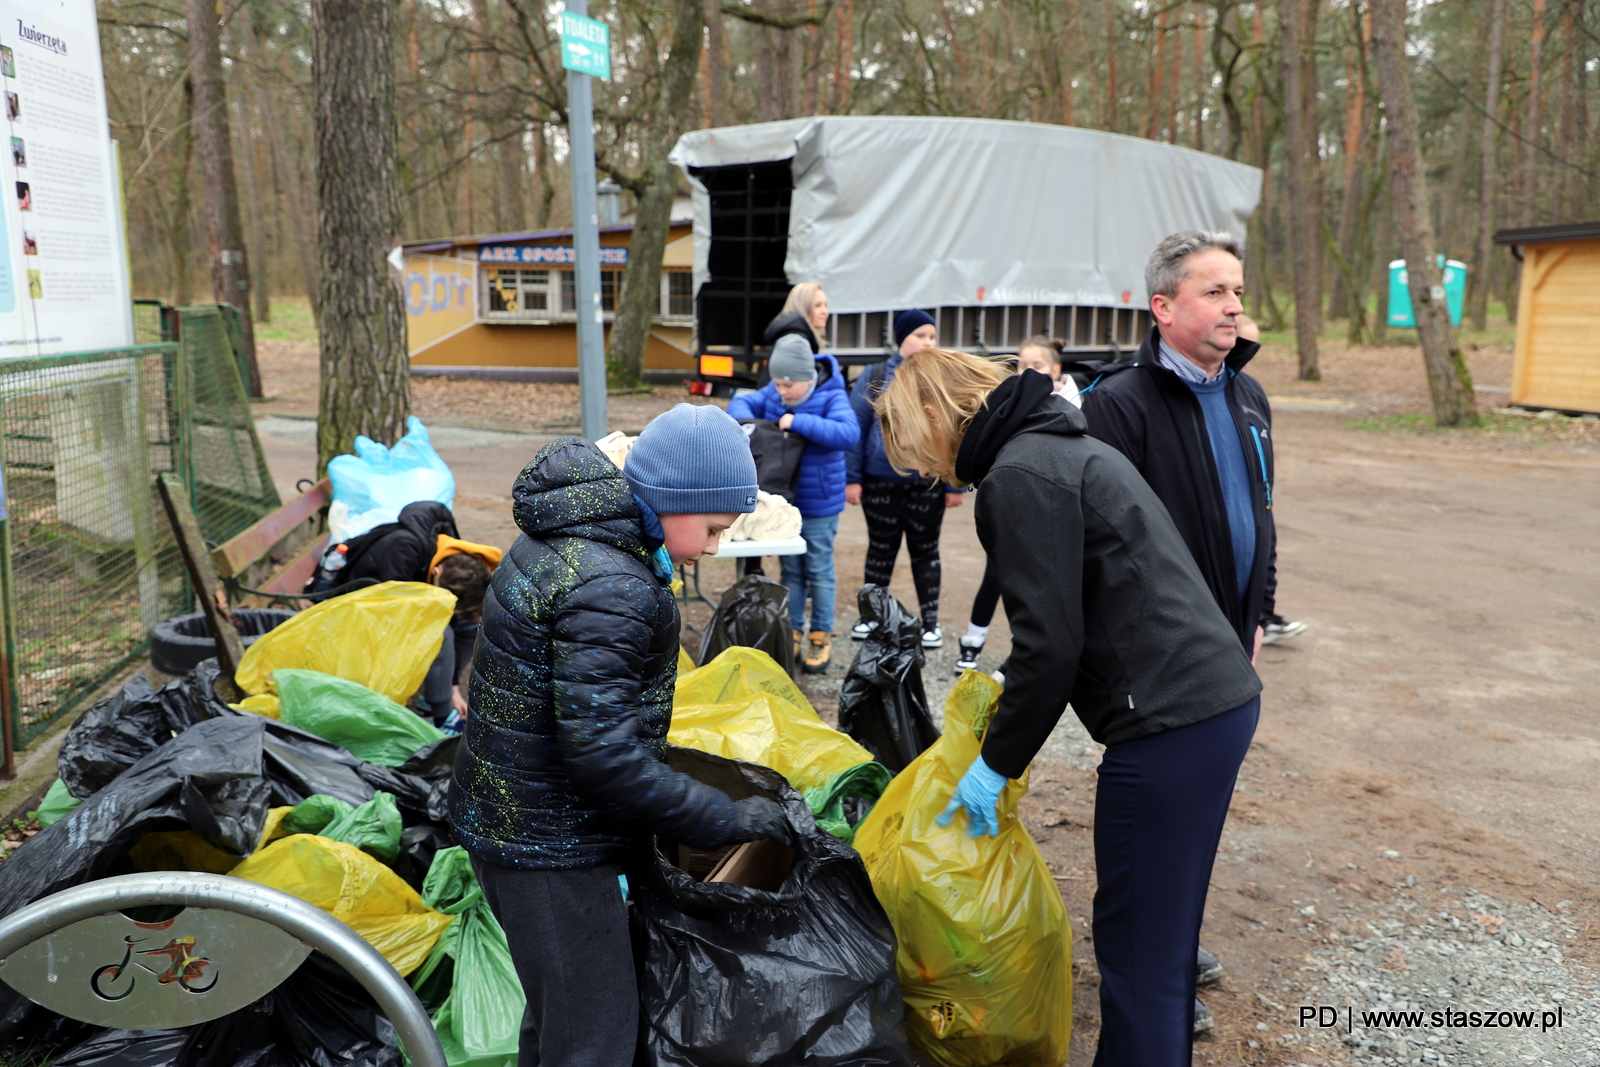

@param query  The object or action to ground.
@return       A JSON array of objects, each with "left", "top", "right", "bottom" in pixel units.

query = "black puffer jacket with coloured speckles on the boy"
[{"left": 450, "top": 438, "right": 736, "bottom": 870}]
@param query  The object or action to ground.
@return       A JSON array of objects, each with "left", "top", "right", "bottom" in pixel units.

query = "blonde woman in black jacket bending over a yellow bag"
[{"left": 877, "top": 349, "right": 1261, "bottom": 1067}]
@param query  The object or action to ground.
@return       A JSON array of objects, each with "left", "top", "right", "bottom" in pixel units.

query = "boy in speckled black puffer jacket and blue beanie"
[{"left": 450, "top": 403, "right": 789, "bottom": 1067}]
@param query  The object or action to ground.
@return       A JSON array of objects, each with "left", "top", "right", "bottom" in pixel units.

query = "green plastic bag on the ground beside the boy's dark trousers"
[{"left": 411, "top": 848, "right": 526, "bottom": 1067}]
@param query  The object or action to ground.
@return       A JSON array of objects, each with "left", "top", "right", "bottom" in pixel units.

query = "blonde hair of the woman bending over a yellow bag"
[{"left": 872, "top": 349, "right": 1011, "bottom": 485}]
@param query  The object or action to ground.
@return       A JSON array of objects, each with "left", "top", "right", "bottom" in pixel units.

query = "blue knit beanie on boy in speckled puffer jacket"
[{"left": 622, "top": 403, "right": 755, "bottom": 515}]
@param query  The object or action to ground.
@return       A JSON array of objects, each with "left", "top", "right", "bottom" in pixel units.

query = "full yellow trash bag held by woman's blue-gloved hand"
[{"left": 854, "top": 670, "right": 1072, "bottom": 1067}]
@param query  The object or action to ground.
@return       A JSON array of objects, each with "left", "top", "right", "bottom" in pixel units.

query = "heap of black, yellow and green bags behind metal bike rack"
[{"left": 0, "top": 582, "right": 523, "bottom": 1067}]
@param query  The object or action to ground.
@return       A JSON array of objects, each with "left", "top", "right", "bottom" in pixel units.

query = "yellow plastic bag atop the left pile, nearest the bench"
[{"left": 234, "top": 582, "right": 456, "bottom": 703}]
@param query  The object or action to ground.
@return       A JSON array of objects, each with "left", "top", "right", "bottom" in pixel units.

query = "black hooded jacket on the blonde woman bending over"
[{"left": 955, "top": 371, "right": 1261, "bottom": 777}]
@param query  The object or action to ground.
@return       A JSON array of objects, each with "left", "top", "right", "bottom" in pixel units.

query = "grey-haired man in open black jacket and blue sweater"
[{"left": 1083, "top": 230, "right": 1277, "bottom": 1029}]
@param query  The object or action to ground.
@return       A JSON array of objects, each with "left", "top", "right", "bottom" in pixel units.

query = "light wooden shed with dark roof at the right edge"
[{"left": 1494, "top": 222, "right": 1600, "bottom": 413}]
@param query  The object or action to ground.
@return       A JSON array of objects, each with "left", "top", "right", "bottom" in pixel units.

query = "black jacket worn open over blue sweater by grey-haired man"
[{"left": 1083, "top": 326, "right": 1278, "bottom": 649}]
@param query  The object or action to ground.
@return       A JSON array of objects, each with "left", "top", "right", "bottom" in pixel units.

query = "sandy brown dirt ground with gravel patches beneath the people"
[{"left": 259, "top": 340, "right": 1600, "bottom": 1067}]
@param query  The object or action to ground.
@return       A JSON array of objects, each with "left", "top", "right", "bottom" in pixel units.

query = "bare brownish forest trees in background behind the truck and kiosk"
[{"left": 99, "top": 0, "right": 1600, "bottom": 371}]
